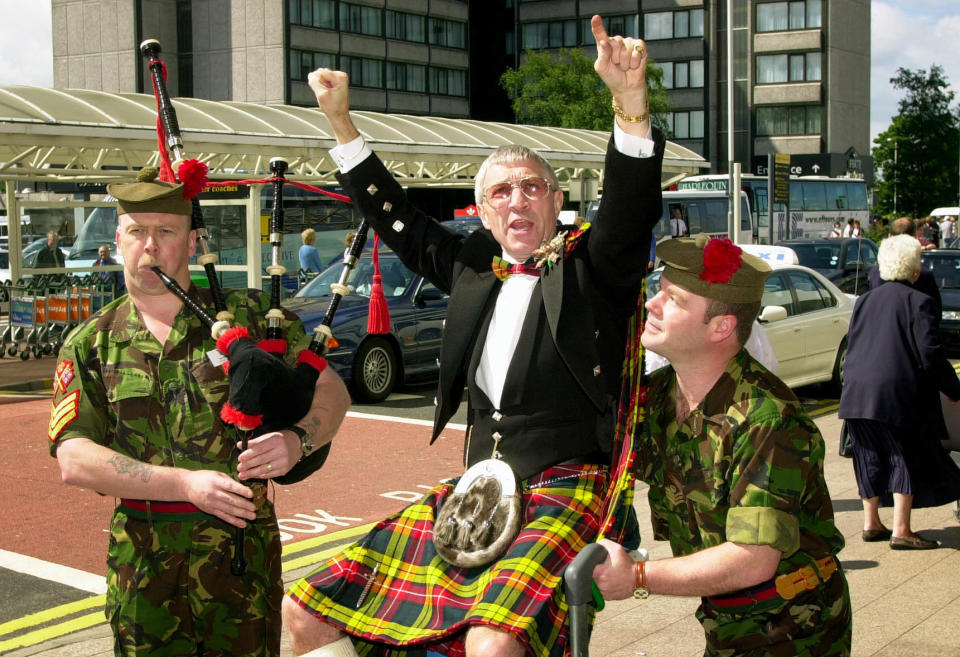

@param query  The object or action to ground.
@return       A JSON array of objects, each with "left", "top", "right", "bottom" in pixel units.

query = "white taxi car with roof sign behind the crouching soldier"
[{"left": 647, "top": 244, "right": 855, "bottom": 395}]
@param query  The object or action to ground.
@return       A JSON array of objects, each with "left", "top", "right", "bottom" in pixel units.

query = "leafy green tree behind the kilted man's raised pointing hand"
[{"left": 500, "top": 49, "right": 671, "bottom": 130}]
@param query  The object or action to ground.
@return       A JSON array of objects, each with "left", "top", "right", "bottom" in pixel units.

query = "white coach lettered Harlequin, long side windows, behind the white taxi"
[{"left": 677, "top": 174, "right": 870, "bottom": 241}]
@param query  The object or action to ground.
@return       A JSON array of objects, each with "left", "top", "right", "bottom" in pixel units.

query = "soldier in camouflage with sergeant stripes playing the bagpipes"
[{"left": 49, "top": 174, "right": 349, "bottom": 656}]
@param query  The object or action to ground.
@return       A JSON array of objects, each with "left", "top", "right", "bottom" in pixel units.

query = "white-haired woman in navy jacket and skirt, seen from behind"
[{"left": 839, "top": 235, "right": 960, "bottom": 550}]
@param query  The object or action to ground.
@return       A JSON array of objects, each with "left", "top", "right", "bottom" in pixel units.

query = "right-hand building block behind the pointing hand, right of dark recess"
[{"left": 506, "top": 0, "right": 872, "bottom": 178}]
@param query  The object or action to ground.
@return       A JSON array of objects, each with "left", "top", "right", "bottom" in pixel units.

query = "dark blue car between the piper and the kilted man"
[{"left": 283, "top": 219, "right": 481, "bottom": 403}]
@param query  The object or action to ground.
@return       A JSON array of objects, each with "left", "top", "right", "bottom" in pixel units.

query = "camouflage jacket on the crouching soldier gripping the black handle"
[{"left": 636, "top": 350, "right": 844, "bottom": 574}]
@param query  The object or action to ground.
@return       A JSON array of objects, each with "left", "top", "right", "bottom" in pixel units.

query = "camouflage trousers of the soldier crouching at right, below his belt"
[{"left": 697, "top": 569, "right": 853, "bottom": 657}]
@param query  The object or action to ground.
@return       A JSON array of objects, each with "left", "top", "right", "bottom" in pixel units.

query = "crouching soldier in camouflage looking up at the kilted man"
[{"left": 594, "top": 236, "right": 852, "bottom": 657}]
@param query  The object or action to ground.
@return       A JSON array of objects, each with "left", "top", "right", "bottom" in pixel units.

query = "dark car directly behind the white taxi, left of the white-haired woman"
[{"left": 777, "top": 237, "right": 877, "bottom": 294}]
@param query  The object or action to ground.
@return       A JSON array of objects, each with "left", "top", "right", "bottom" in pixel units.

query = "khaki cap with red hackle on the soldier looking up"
[{"left": 657, "top": 233, "right": 770, "bottom": 303}]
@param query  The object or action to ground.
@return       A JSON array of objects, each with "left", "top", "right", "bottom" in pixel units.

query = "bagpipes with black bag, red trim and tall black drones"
[{"left": 140, "top": 39, "right": 378, "bottom": 575}]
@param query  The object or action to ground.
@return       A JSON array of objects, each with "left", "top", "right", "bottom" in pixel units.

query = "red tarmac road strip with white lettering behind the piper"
[{"left": 0, "top": 399, "right": 463, "bottom": 574}]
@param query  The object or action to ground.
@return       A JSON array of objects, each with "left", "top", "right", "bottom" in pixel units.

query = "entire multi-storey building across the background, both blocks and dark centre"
[{"left": 53, "top": 0, "right": 872, "bottom": 179}]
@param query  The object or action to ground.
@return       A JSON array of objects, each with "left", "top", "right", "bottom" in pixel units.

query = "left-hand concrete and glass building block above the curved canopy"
[{"left": 52, "top": 0, "right": 470, "bottom": 117}]
